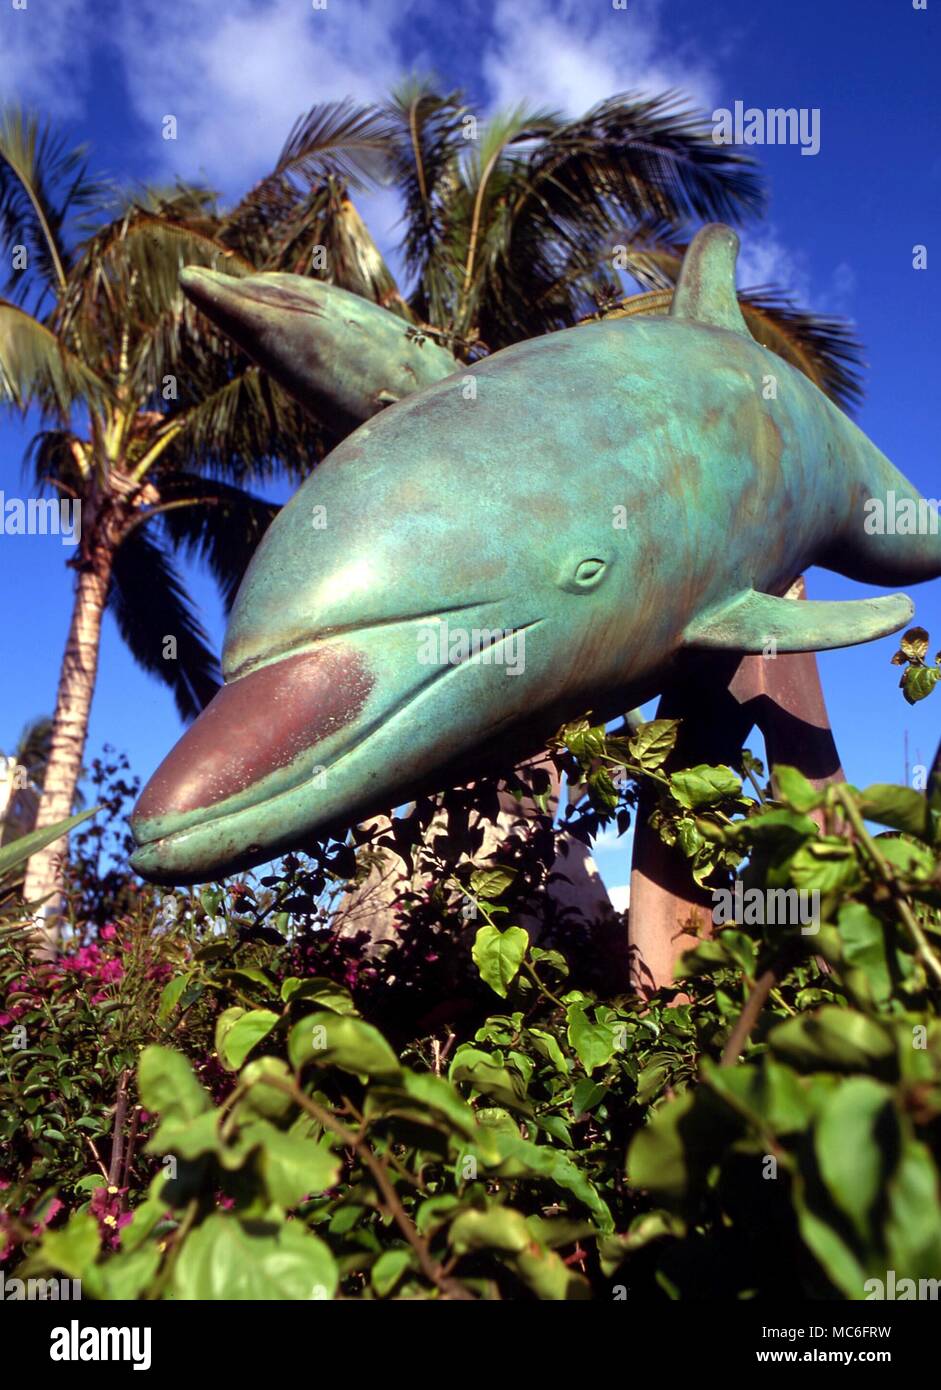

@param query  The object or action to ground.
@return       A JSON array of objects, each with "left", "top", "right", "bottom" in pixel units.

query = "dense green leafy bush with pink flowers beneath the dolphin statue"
[{"left": 0, "top": 678, "right": 941, "bottom": 1300}]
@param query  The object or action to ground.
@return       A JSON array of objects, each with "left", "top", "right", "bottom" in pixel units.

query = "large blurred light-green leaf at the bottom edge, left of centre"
[{"left": 172, "top": 1213, "right": 338, "bottom": 1302}]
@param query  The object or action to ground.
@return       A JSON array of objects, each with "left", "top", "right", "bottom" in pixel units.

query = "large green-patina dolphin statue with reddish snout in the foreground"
[{"left": 131, "top": 225, "right": 941, "bottom": 884}]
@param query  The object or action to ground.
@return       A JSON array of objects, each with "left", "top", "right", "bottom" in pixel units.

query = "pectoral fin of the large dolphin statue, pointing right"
[{"left": 684, "top": 589, "right": 915, "bottom": 652}]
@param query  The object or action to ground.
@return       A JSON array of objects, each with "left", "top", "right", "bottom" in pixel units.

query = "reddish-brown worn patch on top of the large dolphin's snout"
[{"left": 132, "top": 646, "right": 373, "bottom": 824}]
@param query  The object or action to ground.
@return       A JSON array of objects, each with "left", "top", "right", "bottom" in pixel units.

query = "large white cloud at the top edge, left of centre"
[{"left": 111, "top": 0, "right": 409, "bottom": 193}]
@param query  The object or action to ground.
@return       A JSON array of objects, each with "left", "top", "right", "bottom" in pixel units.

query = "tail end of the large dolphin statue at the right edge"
[{"left": 819, "top": 416, "right": 941, "bottom": 585}]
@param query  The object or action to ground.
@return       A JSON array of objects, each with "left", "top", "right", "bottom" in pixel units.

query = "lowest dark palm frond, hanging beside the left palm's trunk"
[{"left": 108, "top": 523, "right": 221, "bottom": 719}]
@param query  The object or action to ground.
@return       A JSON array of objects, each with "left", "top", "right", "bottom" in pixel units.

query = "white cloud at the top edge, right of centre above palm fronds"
[{"left": 481, "top": 0, "right": 716, "bottom": 115}]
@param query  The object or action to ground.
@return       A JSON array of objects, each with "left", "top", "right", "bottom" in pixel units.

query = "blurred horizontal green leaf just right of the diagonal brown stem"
[{"left": 767, "top": 1004, "right": 895, "bottom": 1077}]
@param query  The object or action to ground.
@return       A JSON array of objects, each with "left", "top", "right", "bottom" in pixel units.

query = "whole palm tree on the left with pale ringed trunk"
[{"left": 0, "top": 107, "right": 397, "bottom": 934}]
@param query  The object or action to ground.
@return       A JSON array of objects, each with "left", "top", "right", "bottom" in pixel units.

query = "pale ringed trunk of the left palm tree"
[{"left": 24, "top": 546, "right": 113, "bottom": 954}]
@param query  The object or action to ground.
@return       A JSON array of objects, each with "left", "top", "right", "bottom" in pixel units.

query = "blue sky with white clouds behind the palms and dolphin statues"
[{"left": 0, "top": 0, "right": 941, "bottom": 883}]
